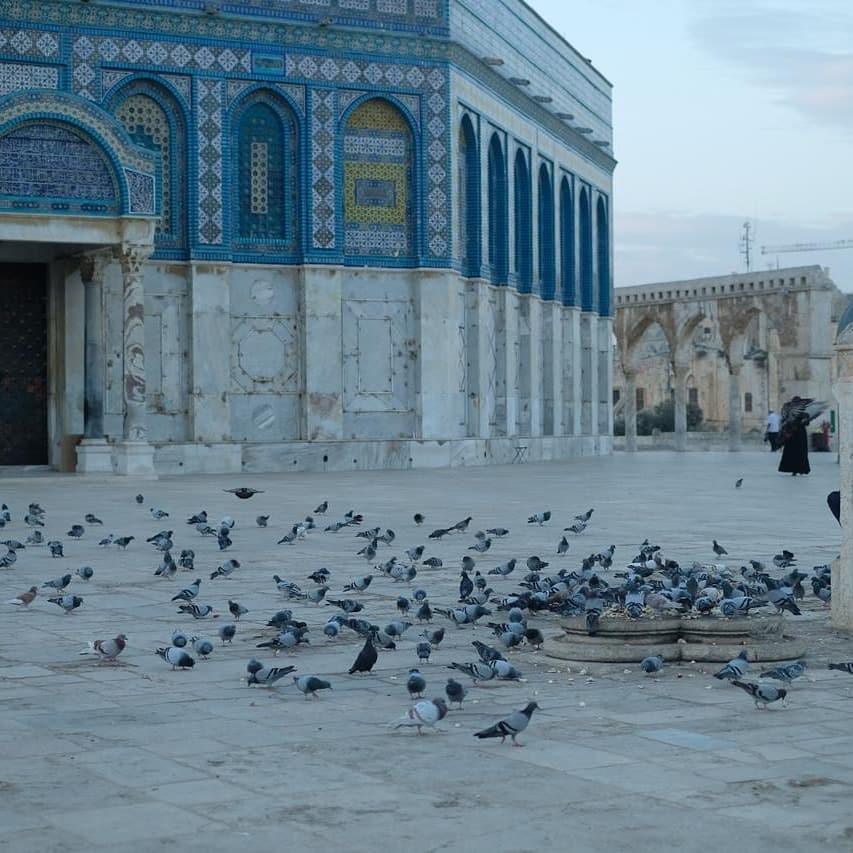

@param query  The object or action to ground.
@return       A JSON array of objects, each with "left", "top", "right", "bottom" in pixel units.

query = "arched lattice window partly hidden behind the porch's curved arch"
[{"left": 111, "top": 80, "right": 187, "bottom": 249}]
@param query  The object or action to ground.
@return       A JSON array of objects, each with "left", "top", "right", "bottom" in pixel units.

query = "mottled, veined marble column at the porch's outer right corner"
[{"left": 115, "top": 244, "right": 154, "bottom": 476}]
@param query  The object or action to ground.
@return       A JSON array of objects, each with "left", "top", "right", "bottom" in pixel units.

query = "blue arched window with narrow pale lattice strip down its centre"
[{"left": 234, "top": 98, "right": 299, "bottom": 251}]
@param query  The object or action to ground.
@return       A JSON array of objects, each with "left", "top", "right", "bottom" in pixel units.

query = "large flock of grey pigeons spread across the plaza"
[{"left": 5, "top": 487, "right": 853, "bottom": 746}]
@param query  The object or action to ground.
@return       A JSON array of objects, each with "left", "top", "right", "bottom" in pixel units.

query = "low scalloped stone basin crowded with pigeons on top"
[{"left": 545, "top": 616, "right": 806, "bottom": 663}]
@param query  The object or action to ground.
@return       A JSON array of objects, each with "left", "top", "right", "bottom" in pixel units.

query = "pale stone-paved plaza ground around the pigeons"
[{"left": 0, "top": 452, "right": 853, "bottom": 853}]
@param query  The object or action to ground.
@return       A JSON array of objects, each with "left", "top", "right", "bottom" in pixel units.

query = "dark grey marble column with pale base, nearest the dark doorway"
[{"left": 77, "top": 252, "right": 112, "bottom": 474}]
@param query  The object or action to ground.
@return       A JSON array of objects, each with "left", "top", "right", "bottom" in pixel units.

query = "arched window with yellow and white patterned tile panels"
[{"left": 343, "top": 98, "right": 415, "bottom": 259}]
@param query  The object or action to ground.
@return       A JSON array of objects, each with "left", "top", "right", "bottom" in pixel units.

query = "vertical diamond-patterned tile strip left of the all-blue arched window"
[{"left": 195, "top": 78, "right": 225, "bottom": 246}]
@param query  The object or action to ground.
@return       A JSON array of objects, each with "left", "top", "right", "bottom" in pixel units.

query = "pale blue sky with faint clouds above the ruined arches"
[{"left": 528, "top": 0, "right": 853, "bottom": 291}]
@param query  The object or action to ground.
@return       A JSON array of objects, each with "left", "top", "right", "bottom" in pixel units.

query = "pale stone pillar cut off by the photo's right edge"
[{"left": 832, "top": 326, "right": 853, "bottom": 631}]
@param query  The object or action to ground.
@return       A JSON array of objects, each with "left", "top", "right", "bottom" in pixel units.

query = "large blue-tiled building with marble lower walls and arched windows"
[{"left": 0, "top": 0, "right": 615, "bottom": 474}]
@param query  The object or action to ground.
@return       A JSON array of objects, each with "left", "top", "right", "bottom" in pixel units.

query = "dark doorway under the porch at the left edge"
[{"left": 0, "top": 264, "right": 47, "bottom": 465}]
